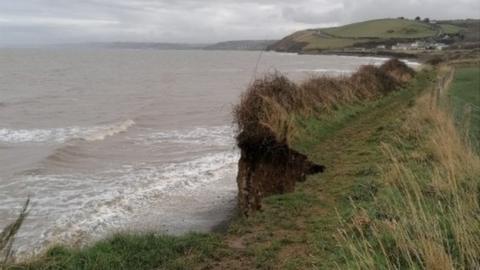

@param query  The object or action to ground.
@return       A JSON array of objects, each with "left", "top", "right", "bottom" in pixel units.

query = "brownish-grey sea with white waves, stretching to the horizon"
[{"left": 0, "top": 48, "right": 408, "bottom": 256}]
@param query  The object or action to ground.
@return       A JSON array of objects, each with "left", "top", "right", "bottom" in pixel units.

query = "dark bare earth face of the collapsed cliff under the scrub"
[{"left": 237, "top": 138, "right": 324, "bottom": 216}]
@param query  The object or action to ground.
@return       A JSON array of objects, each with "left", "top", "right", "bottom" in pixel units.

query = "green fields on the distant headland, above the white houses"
[{"left": 270, "top": 19, "right": 463, "bottom": 52}]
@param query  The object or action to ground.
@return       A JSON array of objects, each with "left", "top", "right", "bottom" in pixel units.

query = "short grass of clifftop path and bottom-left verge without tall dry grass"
[{"left": 10, "top": 70, "right": 448, "bottom": 269}]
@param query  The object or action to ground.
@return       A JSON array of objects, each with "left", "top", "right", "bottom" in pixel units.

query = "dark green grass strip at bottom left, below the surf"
[{"left": 7, "top": 234, "right": 221, "bottom": 270}]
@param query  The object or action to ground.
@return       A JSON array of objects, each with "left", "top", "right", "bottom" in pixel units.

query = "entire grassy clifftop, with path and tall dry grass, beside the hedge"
[{"left": 6, "top": 63, "right": 480, "bottom": 269}]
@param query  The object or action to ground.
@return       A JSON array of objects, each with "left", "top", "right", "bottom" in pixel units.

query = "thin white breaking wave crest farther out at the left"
[{"left": 0, "top": 120, "right": 135, "bottom": 143}]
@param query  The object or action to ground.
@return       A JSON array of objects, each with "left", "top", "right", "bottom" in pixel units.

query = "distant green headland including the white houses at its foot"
[{"left": 268, "top": 16, "right": 480, "bottom": 59}]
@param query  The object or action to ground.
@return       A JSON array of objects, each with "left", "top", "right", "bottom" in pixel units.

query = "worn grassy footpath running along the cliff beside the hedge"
[{"left": 200, "top": 70, "right": 431, "bottom": 269}]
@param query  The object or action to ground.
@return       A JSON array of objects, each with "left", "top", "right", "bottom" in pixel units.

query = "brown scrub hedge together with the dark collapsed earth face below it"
[{"left": 234, "top": 59, "right": 415, "bottom": 215}]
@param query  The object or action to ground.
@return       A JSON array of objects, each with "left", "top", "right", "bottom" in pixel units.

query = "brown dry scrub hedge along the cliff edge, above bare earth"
[{"left": 234, "top": 59, "right": 415, "bottom": 149}]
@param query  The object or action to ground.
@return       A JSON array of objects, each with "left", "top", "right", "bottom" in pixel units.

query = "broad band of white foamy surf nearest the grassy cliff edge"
[{"left": 0, "top": 151, "right": 239, "bottom": 255}]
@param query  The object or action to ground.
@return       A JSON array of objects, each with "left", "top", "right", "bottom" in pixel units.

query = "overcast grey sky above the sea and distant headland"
[{"left": 0, "top": 0, "right": 480, "bottom": 45}]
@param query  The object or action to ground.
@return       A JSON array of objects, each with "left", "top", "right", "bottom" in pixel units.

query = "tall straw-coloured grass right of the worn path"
[{"left": 340, "top": 69, "right": 480, "bottom": 269}]
